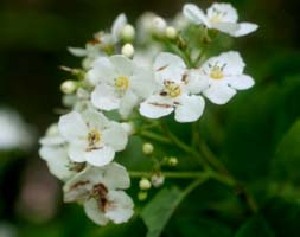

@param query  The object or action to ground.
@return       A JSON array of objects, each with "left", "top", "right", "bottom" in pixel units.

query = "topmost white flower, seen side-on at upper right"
[{"left": 183, "top": 3, "right": 257, "bottom": 37}]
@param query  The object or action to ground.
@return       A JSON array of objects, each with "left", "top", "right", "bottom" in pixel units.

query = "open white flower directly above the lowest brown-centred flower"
[{"left": 58, "top": 110, "right": 128, "bottom": 166}]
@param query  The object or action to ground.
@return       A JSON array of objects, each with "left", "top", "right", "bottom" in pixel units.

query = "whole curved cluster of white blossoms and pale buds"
[{"left": 40, "top": 3, "right": 257, "bottom": 225}]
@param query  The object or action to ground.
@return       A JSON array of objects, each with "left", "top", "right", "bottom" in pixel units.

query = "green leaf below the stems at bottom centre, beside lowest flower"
[{"left": 141, "top": 187, "right": 184, "bottom": 237}]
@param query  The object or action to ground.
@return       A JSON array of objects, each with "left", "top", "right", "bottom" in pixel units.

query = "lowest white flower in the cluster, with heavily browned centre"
[{"left": 64, "top": 163, "right": 133, "bottom": 225}]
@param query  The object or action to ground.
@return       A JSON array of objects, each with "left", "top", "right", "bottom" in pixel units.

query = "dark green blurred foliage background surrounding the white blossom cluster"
[{"left": 0, "top": 0, "right": 300, "bottom": 237}]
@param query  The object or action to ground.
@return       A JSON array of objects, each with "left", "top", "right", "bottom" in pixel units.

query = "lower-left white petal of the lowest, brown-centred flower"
[{"left": 83, "top": 198, "right": 109, "bottom": 225}]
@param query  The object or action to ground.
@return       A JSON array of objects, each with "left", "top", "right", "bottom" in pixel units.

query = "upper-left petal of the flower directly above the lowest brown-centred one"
[{"left": 58, "top": 111, "right": 88, "bottom": 141}]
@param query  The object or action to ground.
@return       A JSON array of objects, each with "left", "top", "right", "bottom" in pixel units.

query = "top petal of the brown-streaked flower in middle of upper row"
[{"left": 153, "top": 52, "right": 186, "bottom": 83}]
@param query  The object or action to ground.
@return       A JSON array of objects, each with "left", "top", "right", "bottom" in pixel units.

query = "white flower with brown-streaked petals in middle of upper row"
[{"left": 140, "top": 53, "right": 204, "bottom": 122}]
